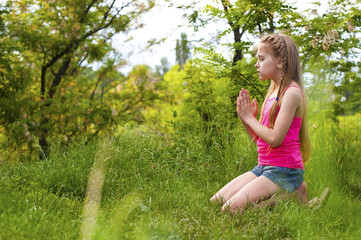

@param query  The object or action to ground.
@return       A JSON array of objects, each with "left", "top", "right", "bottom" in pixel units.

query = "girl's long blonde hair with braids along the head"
[{"left": 260, "top": 34, "right": 311, "bottom": 163}]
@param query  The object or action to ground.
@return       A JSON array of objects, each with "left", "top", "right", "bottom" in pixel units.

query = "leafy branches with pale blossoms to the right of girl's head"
[{"left": 287, "top": 1, "right": 361, "bottom": 116}]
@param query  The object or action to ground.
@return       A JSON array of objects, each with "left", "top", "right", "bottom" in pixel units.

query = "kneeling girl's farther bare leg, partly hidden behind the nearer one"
[{"left": 210, "top": 172, "right": 257, "bottom": 204}]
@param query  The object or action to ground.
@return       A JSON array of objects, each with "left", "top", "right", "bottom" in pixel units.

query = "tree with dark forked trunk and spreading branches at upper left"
[{"left": 5, "top": 0, "right": 153, "bottom": 157}]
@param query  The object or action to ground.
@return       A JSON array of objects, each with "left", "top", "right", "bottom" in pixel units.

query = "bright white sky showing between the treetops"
[{"left": 113, "top": 0, "right": 327, "bottom": 74}]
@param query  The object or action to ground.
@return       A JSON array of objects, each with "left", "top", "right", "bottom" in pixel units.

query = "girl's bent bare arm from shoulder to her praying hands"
[{"left": 238, "top": 88, "right": 302, "bottom": 148}]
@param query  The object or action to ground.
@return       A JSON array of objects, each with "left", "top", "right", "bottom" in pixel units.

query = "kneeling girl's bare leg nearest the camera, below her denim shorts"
[{"left": 222, "top": 176, "right": 282, "bottom": 212}]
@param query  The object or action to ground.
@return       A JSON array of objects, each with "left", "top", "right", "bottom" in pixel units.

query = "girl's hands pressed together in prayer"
[{"left": 237, "top": 88, "right": 258, "bottom": 122}]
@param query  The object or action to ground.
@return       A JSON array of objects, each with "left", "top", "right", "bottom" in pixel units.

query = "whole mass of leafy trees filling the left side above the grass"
[{"left": 0, "top": 0, "right": 153, "bottom": 159}]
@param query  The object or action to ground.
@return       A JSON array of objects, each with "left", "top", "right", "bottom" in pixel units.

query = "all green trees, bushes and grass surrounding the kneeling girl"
[{"left": 0, "top": 0, "right": 361, "bottom": 239}]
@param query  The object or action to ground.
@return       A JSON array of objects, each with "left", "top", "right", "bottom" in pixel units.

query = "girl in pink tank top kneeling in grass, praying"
[{"left": 211, "top": 34, "right": 310, "bottom": 212}]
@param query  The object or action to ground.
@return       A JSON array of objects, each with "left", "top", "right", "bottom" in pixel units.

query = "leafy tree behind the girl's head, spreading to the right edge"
[{"left": 179, "top": 0, "right": 360, "bottom": 116}]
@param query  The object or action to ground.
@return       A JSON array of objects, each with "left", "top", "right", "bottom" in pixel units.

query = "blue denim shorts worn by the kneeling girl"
[{"left": 251, "top": 165, "right": 305, "bottom": 193}]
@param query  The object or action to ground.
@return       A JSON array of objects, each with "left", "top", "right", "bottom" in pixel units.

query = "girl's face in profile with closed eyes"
[{"left": 255, "top": 43, "right": 282, "bottom": 81}]
